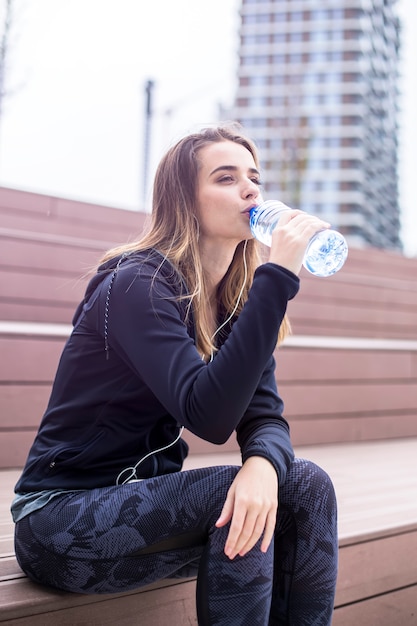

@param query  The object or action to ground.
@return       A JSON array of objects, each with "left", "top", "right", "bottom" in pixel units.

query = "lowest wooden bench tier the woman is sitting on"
[{"left": 0, "top": 439, "right": 417, "bottom": 626}]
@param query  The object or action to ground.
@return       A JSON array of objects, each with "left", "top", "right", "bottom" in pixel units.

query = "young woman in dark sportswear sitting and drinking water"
[{"left": 12, "top": 127, "right": 337, "bottom": 626}]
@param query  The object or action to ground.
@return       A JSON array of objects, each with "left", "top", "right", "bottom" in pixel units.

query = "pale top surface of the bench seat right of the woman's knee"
[{"left": 295, "top": 437, "right": 417, "bottom": 540}]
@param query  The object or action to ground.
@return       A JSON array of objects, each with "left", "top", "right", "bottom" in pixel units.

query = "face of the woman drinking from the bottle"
[{"left": 197, "top": 141, "right": 261, "bottom": 246}]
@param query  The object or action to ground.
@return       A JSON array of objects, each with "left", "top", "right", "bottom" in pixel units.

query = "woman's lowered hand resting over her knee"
[{"left": 216, "top": 456, "right": 278, "bottom": 559}]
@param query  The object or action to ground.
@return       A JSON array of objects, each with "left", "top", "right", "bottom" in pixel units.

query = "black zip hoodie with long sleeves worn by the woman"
[{"left": 16, "top": 251, "right": 299, "bottom": 493}]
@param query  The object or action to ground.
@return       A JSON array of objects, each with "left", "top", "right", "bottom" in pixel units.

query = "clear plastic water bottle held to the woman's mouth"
[{"left": 249, "top": 200, "right": 348, "bottom": 277}]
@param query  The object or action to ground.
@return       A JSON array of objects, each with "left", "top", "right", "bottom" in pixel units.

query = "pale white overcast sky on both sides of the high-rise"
[{"left": 0, "top": 0, "right": 417, "bottom": 256}]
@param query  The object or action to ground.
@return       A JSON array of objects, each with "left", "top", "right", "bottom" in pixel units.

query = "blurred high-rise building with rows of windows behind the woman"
[{"left": 233, "top": 0, "right": 401, "bottom": 250}]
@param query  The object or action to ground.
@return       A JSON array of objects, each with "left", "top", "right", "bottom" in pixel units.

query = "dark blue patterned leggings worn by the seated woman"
[{"left": 16, "top": 459, "right": 337, "bottom": 626}]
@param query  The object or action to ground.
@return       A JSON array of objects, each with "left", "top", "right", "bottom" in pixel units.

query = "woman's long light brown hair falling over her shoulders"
[{"left": 101, "top": 125, "right": 290, "bottom": 356}]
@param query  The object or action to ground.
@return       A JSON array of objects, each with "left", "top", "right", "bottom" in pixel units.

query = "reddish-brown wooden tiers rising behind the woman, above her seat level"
[{"left": 0, "top": 188, "right": 417, "bottom": 468}]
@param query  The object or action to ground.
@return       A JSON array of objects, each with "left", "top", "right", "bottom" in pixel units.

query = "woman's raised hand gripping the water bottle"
[{"left": 269, "top": 209, "right": 330, "bottom": 275}]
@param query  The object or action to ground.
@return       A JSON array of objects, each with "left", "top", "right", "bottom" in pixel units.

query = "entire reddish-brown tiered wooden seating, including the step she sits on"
[{"left": 0, "top": 188, "right": 417, "bottom": 626}]
